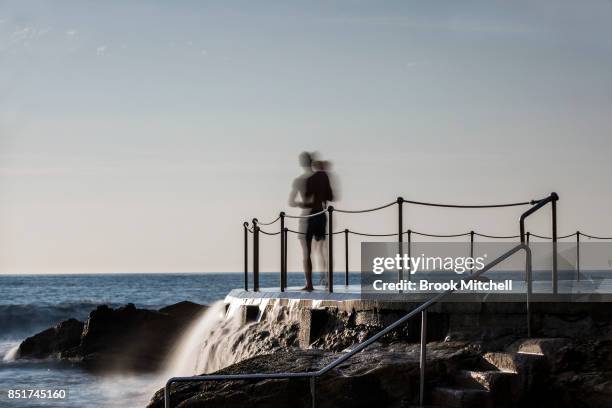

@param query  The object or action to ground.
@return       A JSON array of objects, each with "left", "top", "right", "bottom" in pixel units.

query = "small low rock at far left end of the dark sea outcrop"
[{"left": 17, "top": 319, "right": 83, "bottom": 358}]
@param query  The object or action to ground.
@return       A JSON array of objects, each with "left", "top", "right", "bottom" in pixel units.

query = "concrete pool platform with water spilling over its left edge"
[{"left": 225, "top": 286, "right": 612, "bottom": 347}]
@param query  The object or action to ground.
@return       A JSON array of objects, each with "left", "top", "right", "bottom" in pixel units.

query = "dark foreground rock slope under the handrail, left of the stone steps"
[{"left": 148, "top": 343, "right": 468, "bottom": 408}]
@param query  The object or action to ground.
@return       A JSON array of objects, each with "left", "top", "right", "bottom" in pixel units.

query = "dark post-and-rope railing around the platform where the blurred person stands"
[{"left": 244, "top": 193, "right": 568, "bottom": 293}]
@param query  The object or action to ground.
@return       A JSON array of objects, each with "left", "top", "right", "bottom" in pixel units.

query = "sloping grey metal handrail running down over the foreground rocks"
[{"left": 164, "top": 243, "right": 532, "bottom": 408}]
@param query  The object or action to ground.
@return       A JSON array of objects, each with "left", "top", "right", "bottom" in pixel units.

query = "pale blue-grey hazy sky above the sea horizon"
[{"left": 0, "top": 0, "right": 612, "bottom": 274}]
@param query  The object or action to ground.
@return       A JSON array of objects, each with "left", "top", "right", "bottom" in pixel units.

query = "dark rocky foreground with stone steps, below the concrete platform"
[{"left": 148, "top": 339, "right": 612, "bottom": 408}]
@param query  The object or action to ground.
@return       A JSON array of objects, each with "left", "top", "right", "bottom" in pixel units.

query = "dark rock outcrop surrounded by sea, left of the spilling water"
[{"left": 19, "top": 302, "right": 206, "bottom": 372}]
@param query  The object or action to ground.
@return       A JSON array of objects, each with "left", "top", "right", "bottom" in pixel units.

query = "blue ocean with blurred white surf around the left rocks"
[{"left": 0, "top": 273, "right": 340, "bottom": 408}]
